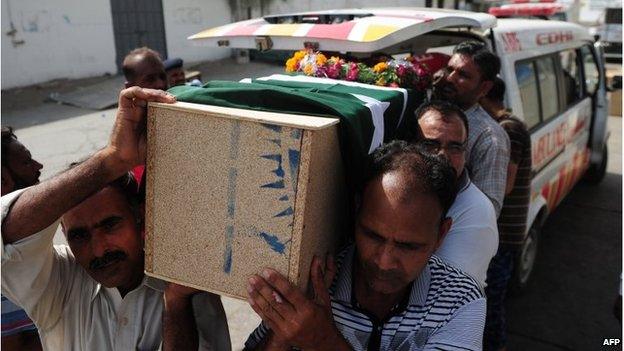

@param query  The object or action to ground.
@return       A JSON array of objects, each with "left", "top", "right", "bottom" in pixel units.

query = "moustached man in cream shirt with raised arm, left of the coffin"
[{"left": 2, "top": 87, "right": 230, "bottom": 350}]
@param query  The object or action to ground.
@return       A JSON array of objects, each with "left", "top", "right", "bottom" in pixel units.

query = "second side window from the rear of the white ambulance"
[{"left": 535, "top": 56, "right": 559, "bottom": 121}]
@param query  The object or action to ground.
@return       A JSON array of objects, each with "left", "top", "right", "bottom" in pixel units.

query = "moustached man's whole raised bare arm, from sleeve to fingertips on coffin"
[{"left": 2, "top": 87, "right": 175, "bottom": 244}]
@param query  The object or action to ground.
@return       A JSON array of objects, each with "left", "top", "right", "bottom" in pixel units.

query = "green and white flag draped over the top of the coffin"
[{"left": 169, "top": 74, "right": 422, "bottom": 188}]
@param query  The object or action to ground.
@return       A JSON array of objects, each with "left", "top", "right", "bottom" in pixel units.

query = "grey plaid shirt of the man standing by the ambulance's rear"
[{"left": 464, "top": 104, "right": 509, "bottom": 217}]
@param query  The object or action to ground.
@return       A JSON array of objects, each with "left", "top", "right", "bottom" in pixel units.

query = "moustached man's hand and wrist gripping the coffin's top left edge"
[{"left": 106, "top": 86, "right": 176, "bottom": 173}]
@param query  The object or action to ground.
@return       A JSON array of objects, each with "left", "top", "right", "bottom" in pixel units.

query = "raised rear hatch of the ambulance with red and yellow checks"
[{"left": 188, "top": 7, "right": 496, "bottom": 52}]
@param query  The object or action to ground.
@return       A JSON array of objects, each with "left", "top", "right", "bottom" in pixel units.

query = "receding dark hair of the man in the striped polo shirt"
[{"left": 365, "top": 140, "right": 457, "bottom": 218}]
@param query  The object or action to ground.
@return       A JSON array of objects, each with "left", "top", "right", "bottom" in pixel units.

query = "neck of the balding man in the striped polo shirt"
[{"left": 353, "top": 265, "right": 411, "bottom": 320}]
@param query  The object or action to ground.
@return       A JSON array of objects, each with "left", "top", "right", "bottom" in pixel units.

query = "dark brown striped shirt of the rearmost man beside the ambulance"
[{"left": 498, "top": 113, "right": 531, "bottom": 250}]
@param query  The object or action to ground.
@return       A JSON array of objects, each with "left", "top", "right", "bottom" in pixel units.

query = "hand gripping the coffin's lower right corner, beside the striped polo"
[{"left": 247, "top": 256, "right": 350, "bottom": 350}]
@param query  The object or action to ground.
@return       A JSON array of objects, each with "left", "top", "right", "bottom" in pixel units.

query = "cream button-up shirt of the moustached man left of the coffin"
[{"left": 2, "top": 190, "right": 231, "bottom": 351}]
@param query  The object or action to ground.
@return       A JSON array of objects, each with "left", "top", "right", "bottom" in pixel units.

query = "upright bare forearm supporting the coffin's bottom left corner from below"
[{"left": 163, "top": 293, "right": 199, "bottom": 351}]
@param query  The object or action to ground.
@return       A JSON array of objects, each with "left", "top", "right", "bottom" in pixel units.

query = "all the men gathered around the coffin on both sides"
[{"left": 2, "top": 42, "right": 531, "bottom": 350}]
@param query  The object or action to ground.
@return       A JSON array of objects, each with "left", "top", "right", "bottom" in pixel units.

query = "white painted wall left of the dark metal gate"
[{"left": 1, "top": 0, "right": 117, "bottom": 89}]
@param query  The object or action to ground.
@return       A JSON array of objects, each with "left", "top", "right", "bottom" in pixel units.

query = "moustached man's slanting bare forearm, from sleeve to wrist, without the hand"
[{"left": 2, "top": 149, "right": 127, "bottom": 244}]
